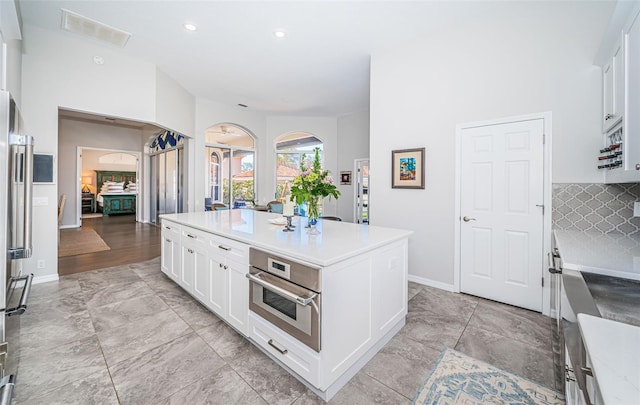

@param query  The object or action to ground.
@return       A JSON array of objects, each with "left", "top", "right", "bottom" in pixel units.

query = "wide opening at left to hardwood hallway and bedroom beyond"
[{"left": 57, "top": 109, "right": 161, "bottom": 275}]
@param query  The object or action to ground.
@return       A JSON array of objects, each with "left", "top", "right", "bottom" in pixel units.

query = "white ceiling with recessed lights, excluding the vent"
[{"left": 19, "top": 0, "right": 608, "bottom": 116}]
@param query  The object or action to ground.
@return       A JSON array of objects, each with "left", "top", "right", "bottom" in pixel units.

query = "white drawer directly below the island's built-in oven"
[{"left": 249, "top": 313, "right": 321, "bottom": 389}]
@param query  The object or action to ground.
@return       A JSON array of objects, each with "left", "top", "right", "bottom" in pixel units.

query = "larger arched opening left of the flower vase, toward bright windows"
[{"left": 205, "top": 124, "right": 255, "bottom": 208}]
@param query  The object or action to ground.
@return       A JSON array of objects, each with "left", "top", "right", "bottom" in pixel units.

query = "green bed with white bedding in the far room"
[{"left": 95, "top": 170, "right": 137, "bottom": 216}]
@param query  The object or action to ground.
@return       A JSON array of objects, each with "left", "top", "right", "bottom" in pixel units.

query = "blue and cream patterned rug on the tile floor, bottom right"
[{"left": 413, "top": 349, "right": 564, "bottom": 405}]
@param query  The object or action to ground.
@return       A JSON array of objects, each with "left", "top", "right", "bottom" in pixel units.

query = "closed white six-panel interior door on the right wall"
[{"left": 460, "top": 119, "right": 544, "bottom": 311}]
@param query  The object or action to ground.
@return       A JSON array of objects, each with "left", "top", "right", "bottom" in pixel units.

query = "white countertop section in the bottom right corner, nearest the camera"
[{"left": 578, "top": 314, "right": 640, "bottom": 405}]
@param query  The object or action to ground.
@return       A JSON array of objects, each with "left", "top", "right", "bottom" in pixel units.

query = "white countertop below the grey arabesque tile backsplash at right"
[{"left": 553, "top": 230, "right": 640, "bottom": 280}]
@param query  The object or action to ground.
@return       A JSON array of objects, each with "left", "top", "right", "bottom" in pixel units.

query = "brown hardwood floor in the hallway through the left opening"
[{"left": 58, "top": 215, "right": 161, "bottom": 276}]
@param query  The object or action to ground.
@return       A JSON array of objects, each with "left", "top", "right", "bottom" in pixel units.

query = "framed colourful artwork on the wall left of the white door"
[{"left": 391, "top": 148, "right": 425, "bottom": 189}]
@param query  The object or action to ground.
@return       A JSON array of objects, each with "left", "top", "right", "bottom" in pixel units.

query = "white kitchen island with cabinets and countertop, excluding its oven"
[{"left": 161, "top": 210, "right": 411, "bottom": 400}]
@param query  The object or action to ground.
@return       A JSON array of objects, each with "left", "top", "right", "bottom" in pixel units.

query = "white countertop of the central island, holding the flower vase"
[{"left": 160, "top": 209, "right": 412, "bottom": 267}]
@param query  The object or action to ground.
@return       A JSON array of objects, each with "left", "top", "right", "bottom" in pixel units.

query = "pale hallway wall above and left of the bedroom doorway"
[{"left": 57, "top": 117, "right": 142, "bottom": 226}]
